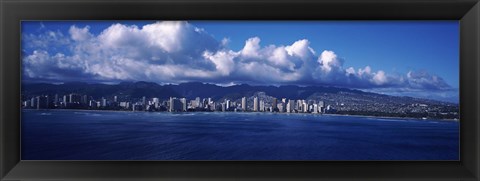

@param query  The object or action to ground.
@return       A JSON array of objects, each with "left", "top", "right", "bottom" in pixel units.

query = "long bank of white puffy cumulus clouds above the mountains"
[{"left": 23, "top": 21, "right": 450, "bottom": 90}]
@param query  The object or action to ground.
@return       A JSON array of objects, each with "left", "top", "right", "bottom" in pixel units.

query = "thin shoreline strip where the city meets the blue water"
[{"left": 21, "top": 108, "right": 460, "bottom": 122}]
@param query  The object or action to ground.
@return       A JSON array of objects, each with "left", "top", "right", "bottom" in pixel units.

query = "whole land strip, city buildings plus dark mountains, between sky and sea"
[{"left": 22, "top": 82, "right": 459, "bottom": 120}]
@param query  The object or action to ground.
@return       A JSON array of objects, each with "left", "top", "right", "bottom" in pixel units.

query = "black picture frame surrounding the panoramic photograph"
[{"left": 0, "top": 0, "right": 480, "bottom": 181}]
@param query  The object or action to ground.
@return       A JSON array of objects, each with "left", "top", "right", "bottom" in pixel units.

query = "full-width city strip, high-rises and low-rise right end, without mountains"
[{"left": 22, "top": 92, "right": 459, "bottom": 120}]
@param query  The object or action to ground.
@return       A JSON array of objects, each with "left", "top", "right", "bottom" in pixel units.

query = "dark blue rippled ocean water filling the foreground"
[{"left": 22, "top": 110, "right": 459, "bottom": 160}]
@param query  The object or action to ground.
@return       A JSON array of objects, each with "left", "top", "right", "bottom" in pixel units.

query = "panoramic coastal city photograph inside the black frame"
[{"left": 20, "top": 20, "right": 463, "bottom": 161}]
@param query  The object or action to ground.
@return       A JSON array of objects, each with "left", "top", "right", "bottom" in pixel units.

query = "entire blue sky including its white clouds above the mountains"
[{"left": 21, "top": 21, "right": 459, "bottom": 102}]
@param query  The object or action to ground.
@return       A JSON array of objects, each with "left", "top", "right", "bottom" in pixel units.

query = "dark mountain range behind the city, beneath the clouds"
[{"left": 22, "top": 81, "right": 453, "bottom": 104}]
